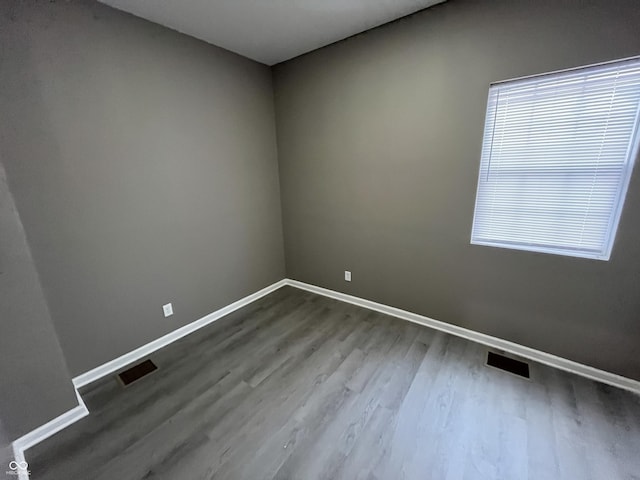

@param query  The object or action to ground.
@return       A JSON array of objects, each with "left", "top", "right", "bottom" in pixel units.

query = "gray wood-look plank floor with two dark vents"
[{"left": 26, "top": 287, "right": 640, "bottom": 480}]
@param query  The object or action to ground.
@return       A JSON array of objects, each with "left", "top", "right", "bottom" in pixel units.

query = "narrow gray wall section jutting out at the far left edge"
[{"left": 0, "top": 163, "right": 78, "bottom": 440}]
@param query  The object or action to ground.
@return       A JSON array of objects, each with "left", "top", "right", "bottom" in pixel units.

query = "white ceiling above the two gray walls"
[{"left": 100, "top": 0, "right": 445, "bottom": 65}]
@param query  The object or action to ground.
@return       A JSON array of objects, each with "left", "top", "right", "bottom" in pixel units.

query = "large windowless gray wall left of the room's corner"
[{"left": 0, "top": 0, "right": 285, "bottom": 376}]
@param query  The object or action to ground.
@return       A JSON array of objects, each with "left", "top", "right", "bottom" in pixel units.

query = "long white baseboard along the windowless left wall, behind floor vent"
[{"left": 73, "top": 279, "right": 286, "bottom": 388}]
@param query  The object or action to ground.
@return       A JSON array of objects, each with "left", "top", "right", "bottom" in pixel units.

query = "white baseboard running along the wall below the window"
[{"left": 286, "top": 279, "right": 640, "bottom": 394}]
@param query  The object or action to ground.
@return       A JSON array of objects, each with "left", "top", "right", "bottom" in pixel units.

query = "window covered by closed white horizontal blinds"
[{"left": 471, "top": 59, "right": 640, "bottom": 260}]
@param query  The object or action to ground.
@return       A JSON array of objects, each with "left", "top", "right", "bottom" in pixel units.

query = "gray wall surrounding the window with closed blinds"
[{"left": 274, "top": 0, "right": 640, "bottom": 379}]
